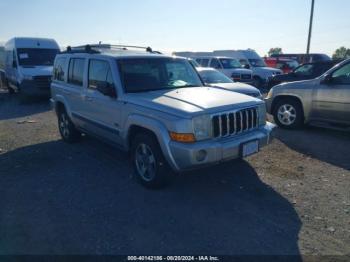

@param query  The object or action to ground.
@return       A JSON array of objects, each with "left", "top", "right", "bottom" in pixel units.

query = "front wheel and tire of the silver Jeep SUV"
[{"left": 131, "top": 133, "right": 173, "bottom": 189}]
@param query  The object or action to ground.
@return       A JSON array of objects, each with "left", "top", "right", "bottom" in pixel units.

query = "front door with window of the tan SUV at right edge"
[{"left": 313, "top": 62, "right": 350, "bottom": 123}]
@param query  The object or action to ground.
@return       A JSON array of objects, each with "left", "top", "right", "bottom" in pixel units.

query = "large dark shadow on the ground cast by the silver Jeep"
[{"left": 0, "top": 138, "right": 301, "bottom": 256}]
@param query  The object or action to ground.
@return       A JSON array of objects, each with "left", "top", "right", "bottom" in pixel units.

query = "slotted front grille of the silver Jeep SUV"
[{"left": 212, "top": 108, "right": 259, "bottom": 138}]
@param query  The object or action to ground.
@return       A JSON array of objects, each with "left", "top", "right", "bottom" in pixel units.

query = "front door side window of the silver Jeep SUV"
[{"left": 88, "top": 59, "right": 114, "bottom": 89}]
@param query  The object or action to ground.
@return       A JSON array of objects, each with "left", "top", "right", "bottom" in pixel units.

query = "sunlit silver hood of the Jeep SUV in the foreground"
[{"left": 126, "top": 87, "right": 261, "bottom": 117}]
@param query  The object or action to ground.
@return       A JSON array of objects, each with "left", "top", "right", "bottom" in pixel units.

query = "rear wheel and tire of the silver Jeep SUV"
[{"left": 57, "top": 109, "right": 81, "bottom": 143}]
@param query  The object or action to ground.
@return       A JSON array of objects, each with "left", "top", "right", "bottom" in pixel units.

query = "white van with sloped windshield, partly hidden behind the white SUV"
[{"left": 213, "top": 49, "right": 282, "bottom": 88}]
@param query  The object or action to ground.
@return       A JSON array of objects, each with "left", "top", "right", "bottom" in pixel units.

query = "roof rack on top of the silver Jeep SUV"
[{"left": 64, "top": 44, "right": 161, "bottom": 54}]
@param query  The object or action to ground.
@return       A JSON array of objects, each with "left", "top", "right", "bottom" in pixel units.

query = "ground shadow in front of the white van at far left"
[{"left": 0, "top": 90, "right": 50, "bottom": 121}]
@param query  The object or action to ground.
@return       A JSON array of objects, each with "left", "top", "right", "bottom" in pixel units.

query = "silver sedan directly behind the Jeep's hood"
[{"left": 196, "top": 67, "right": 262, "bottom": 99}]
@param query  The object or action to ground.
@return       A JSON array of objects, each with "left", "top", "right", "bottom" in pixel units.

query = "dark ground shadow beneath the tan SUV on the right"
[{"left": 276, "top": 126, "right": 350, "bottom": 170}]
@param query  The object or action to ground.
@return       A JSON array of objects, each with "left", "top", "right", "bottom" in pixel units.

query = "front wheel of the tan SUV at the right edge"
[{"left": 273, "top": 98, "right": 304, "bottom": 129}]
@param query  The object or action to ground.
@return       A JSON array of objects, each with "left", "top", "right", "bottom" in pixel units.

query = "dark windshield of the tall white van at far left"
[{"left": 17, "top": 48, "right": 59, "bottom": 66}]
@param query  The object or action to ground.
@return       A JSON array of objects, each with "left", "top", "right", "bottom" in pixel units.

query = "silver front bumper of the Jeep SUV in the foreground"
[{"left": 169, "top": 122, "right": 275, "bottom": 171}]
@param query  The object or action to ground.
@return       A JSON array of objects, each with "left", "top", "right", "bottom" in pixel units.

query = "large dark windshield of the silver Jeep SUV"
[{"left": 118, "top": 58, "right": 203, "bottom": 93}]
